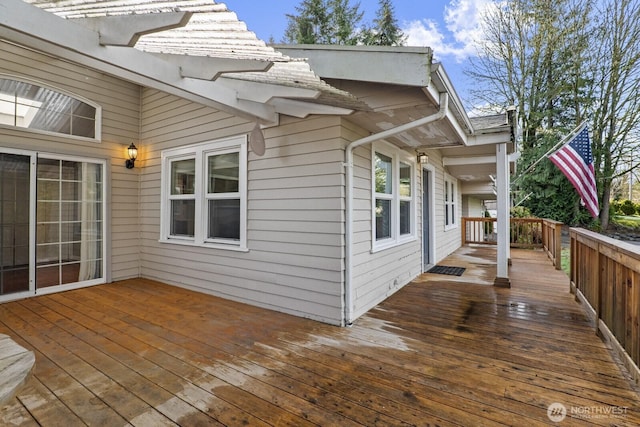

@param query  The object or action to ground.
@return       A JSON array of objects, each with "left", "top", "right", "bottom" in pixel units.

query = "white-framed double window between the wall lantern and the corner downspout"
[{"left": 160, "top": 135, "right": 247, "bottom": 250}]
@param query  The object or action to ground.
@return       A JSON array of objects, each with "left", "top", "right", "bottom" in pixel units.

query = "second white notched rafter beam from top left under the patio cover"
[{"left": 158, "top": 53, "right": 273, "bottom": 80}]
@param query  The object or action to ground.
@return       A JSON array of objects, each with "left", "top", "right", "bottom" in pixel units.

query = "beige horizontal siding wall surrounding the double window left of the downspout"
[{"left": 140, "top": 89, "right": 344, "bottom": 324}]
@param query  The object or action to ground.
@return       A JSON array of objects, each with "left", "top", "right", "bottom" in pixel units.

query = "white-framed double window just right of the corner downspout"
[{"left": 371, "top": 144, "right": 416, "bottom": 251}]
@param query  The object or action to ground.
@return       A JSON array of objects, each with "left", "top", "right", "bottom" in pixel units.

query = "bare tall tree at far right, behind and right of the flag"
[{"left": 585, "top": 0, "right": 640, "bottom": 231}]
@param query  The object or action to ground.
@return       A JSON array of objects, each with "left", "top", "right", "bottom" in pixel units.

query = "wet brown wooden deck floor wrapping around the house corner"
[{"left": 0, "top": 248, "right": 640, "bottom": 427}]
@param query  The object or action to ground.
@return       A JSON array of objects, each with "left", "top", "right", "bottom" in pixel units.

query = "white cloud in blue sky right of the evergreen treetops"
[{"left": 402, "top": 0, "right": 494, "bottom": 62}]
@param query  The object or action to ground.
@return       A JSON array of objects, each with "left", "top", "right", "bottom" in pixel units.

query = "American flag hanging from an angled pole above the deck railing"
[{"left": 549, "top": 126, "right": 600, "bottom": 218}]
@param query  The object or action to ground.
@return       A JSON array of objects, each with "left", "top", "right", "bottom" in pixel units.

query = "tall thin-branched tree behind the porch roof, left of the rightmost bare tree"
[{"left": 467, "top": 0, "right": 592, "bottom": 150}]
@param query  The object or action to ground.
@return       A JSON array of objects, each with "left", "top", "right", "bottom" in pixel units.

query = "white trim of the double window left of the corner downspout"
[{"left": 160, "top": 135, "right": 248, "bottom": 252}]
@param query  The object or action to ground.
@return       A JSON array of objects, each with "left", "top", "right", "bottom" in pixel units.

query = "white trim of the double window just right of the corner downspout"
[{"left": 371, "top": 143, "right": 418, "bottom": 253}]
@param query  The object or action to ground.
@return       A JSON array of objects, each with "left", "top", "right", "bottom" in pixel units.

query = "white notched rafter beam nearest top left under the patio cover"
[{"left": 74, "top": 12, "right": 193, "bottom": 47}]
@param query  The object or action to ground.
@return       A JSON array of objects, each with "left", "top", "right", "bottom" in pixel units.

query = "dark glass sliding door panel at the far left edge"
[{"left": 0, "top": 153, "right": 31, "bottom": 296}]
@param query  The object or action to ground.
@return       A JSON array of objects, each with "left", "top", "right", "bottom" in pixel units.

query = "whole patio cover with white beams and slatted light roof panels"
[{"left": 8, "top": 0, "right": 360, "bottom": 124}]
